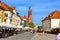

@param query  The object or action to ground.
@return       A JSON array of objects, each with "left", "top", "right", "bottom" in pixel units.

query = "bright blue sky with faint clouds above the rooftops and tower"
[{"left": 1, "top": 0, "right": 60, "bottom": 25}]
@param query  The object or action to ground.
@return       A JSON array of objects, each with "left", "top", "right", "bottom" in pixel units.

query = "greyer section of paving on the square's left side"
[{"left": 0, "top": 32, "right": 34, "bottom": 40}]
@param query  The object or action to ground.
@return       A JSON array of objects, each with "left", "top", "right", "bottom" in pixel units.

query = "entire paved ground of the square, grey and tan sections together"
[{"left": 0, "top": 32, "right": 56, "bottom": 40}]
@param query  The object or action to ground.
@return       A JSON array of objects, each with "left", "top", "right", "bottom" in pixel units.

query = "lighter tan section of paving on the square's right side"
[{"left": 31, "top": 33, "right": 56, "bottom": 40}]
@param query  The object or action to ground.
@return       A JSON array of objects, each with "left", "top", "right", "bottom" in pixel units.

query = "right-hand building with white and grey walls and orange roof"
[{"left": 42, "top": 10, "right": 60, "bottom": 29}]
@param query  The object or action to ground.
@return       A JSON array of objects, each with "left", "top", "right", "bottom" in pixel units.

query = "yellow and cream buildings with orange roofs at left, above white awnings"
[{"left": 0, "top": 1, "right": 20, "bottom": 26}]
